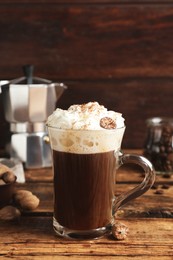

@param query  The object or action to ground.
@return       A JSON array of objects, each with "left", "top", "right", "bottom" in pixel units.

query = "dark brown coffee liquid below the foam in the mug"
[{"left": 53, "top": 150, "right": 116, "bottom": 230}]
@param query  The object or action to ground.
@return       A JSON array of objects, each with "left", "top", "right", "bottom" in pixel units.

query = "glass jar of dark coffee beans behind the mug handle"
[{"left": 144, "top": 117, "right": 173, "bottom": 174}]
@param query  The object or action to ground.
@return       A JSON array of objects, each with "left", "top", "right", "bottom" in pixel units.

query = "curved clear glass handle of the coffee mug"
[{"left": 113, "top": 154, "right": 155, "bottom": 214}]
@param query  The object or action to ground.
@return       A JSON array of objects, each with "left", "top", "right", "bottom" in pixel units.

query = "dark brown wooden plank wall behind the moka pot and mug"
[{"left": 0, "top": 0, "right": 173, "bottom": 148}]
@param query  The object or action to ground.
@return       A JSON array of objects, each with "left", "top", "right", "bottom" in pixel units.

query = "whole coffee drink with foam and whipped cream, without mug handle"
[{"left": 48, "top": 102, "right": 124, "bottom": 234}]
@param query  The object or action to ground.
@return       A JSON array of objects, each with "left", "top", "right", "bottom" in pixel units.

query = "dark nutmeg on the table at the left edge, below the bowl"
[{"left": 0, "top": 206, "right": 21, "bottom": 220}]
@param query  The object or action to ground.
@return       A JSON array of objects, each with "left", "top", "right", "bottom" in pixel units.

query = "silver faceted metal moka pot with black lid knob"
[{"left": 1, "top": 65, "right": 67, "bottom": 169}]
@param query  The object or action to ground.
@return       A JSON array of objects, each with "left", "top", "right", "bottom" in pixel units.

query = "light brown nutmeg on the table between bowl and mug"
[{"left": 14, "top": 190, "right": 40, "bottom": 211}]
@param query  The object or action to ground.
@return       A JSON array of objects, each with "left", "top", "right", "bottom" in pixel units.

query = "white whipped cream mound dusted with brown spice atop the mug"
[{"left": 47, "top": 102, "right": 124, "bottom": 130}]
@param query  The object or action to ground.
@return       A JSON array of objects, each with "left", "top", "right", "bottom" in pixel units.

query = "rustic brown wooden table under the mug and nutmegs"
[{"left": 0, "top": 151, "right": 173, "bottom": 260}]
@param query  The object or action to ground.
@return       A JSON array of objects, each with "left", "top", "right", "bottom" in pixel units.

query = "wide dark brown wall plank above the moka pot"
[{"left": 0, "top": 3, "right": 173, "bottom": 80}]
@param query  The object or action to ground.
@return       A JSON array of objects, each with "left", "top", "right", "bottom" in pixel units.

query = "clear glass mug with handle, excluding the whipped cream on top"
[{"left": 48, "top": 126, "right": 155, "bottom": 239}]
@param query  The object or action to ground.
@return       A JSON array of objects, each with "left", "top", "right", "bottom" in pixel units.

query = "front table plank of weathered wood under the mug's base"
[{"left": 0, "top": 218, "right": 173, "bottom": 259}]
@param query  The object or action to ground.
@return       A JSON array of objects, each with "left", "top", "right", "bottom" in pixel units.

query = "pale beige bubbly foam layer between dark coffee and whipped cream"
[{"left": 48, "top": 127, "right": 125, "bottom": 154}]
